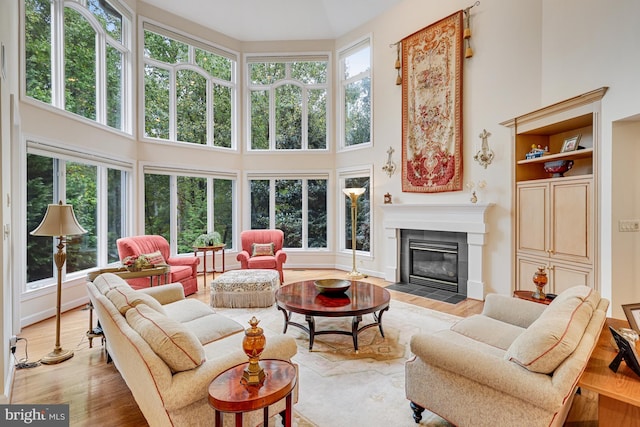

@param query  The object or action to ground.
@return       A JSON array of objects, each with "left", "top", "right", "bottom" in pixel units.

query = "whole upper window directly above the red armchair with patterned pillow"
[{"left": 247, "top": 55, "right": 329, "bottom": 150}]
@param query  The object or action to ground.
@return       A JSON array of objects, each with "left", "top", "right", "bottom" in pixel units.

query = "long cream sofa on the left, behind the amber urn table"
[{"left": 87, "top": 273, "right": 297, "bottom": 427}]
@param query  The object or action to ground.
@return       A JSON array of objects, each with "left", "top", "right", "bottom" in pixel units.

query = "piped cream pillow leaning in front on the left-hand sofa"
[{"left": 126, "top": 304, "right": 205, "bottom": 372}]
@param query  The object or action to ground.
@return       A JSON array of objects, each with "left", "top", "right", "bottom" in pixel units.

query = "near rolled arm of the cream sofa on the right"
[{"left": 408, "top": 333, "right": 569, "bottom": 411}]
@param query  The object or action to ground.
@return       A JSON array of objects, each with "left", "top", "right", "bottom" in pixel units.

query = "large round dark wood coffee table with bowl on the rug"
[{"left": 276, "top": 280, "right": 391, "bottom": 352}]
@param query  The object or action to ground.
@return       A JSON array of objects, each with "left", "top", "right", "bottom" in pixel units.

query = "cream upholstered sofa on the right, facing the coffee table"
[{"left": 405, "top": 286, "right": 609, "bottom": 427}]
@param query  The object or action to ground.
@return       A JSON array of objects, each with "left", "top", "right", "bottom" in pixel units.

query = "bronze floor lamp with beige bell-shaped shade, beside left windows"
[{"left": 31, "top": 201, "right": 87, "bottom": 365}]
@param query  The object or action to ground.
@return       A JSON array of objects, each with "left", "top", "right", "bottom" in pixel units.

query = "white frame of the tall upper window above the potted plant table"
[{"left": 137, "top": 16, "right": 240, "bottom": 152}]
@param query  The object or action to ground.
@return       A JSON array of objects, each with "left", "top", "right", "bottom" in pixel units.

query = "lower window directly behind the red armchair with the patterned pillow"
[{"left": 249, "top": 177, "right": 327, "bottom": 249}]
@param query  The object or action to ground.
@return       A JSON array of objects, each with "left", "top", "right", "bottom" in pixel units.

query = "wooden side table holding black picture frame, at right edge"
[{"left": 578, "top": 318, "right": 640, "bottom": 427}]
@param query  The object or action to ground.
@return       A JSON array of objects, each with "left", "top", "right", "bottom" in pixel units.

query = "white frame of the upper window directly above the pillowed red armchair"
[{"left": 242, "top": 51, "right": 333, "bottom": 153}]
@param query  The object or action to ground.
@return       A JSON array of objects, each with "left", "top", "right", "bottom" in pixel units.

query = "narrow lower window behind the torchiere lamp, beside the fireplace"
[{"left": 340, "top": 174, "right": 371, "bottom": 252}]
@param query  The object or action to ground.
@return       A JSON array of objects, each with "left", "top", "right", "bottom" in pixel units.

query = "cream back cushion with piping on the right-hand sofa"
[{"left": 505, "top": 286, "right": 600, "bottom": 374}]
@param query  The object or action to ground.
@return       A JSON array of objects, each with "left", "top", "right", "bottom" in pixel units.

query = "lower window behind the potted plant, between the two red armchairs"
[{"left": 144, "top": 170, "right": 235, "bottom": 254}]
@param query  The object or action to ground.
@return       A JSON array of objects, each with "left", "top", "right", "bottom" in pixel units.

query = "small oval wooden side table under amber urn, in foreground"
[{"left": 209, "top": 359, "right": 297, "bottom": 427}]
